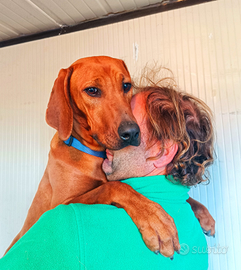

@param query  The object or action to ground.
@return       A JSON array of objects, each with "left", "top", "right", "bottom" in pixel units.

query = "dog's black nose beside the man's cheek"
[{"left": 118, "top": 122, "right": 140, "bottom": 146}]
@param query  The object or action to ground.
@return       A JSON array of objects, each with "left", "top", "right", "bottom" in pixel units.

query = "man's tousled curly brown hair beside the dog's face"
[{"left": 138, "top": 81, "right": 214, "bottom": 186}]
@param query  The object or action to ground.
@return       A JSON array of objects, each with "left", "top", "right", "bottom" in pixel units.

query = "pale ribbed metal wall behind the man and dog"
[{"left": 0, "top": 0, "right": 241, "bottom": 270}]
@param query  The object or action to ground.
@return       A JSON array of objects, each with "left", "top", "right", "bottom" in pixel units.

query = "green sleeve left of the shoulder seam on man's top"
[{"left": 0, "top": 205, "right": 81, "bottom": 270}]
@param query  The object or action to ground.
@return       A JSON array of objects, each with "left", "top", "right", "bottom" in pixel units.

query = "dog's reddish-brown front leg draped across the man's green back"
[{"left": 69, "top": 181, "right": 180, "bottom": 257}]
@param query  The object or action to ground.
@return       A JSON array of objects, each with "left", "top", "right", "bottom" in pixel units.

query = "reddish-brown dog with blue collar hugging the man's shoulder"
[{"left": 8, "top": 56, "right": 180, "bottom": 256}]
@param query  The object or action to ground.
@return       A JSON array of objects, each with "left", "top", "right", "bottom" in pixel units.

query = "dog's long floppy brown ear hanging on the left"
[{"left": 46, "top": 68, "right": 73, "bottom": 140}]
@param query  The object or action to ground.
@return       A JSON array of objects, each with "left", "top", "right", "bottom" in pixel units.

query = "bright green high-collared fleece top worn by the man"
[{"left": 0, "top": 176, "right": 208, "bottom": 270}]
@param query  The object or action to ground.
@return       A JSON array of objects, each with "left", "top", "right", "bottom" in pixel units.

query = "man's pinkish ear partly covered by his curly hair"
[{"left": 153, "top": 142, "right": 178, "bottom": 168}]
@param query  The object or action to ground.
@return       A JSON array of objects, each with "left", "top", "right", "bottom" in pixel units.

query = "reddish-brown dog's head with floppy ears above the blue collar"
[{"left": 46, "top": 56, "right": 140, "bottom": 150}]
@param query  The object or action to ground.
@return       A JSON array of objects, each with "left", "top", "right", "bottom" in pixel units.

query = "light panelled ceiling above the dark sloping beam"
[{"left": 0, "top": 0, "right": 209, "bottom": 47}]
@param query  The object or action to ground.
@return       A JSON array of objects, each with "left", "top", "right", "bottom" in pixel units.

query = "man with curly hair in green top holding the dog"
[{"left": 0, "top": 79, "right": 213, "bottom": 270}]
